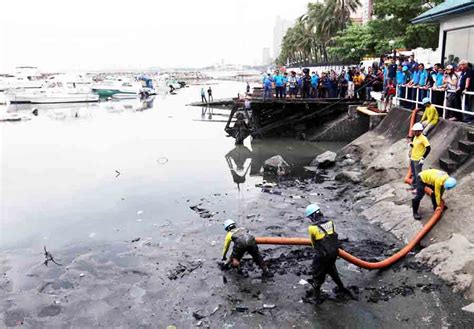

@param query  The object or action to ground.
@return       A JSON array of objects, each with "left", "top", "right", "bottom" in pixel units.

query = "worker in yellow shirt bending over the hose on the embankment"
[{"left": 412, "top": 169, "right": 456, "bottom": 220}]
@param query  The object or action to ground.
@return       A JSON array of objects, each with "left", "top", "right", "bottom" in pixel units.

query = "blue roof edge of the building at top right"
[{"left": 411, "top": 0, "right": 474, "bottom": 24}]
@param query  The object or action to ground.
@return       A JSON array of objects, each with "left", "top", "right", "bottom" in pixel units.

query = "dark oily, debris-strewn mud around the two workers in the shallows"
[{"left": 0, "top": 159, "right": 474, "bottom": 328}]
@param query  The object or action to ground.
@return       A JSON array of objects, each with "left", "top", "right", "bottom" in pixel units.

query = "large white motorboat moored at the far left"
[{"left": 5, "top": 75, "right": 99, "bottom": 104}]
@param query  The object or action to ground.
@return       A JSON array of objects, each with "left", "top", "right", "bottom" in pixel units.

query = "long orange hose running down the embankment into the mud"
[{"left": 255, "top": 108, "right": 444, "bottom": 270}]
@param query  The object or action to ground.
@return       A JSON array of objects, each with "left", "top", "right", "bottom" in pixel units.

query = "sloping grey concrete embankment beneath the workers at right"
[{"left": 326, "top": 109, "right": 474, "bottom": 300}]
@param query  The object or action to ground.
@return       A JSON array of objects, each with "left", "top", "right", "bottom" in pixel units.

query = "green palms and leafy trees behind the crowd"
[{"left": 277, "top": 0, "right": 443, "bottom": 64}]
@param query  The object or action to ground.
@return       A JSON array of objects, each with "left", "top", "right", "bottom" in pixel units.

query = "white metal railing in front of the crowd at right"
[{"left": 394, "top": 85, "right": 474, "bottom": 119}]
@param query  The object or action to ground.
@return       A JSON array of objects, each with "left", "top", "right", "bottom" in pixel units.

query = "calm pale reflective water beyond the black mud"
[{"left": 0, "top": 82, "right": 341, "bottom": 250}]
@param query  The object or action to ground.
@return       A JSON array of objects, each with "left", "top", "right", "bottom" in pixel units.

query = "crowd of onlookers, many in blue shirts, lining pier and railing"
[{"left": 262, "top": 56, "right": 474, "bottom": 122}]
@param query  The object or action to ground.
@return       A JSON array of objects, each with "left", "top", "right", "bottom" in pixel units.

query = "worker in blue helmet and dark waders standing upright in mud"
[{"left": 306, "top": 203, "right": 352, "bottom": 303}]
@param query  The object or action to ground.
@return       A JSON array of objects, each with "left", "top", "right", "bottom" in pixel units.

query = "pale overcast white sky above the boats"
[{"left": 0, "top": 0, "right": 308, "bottom": 73}]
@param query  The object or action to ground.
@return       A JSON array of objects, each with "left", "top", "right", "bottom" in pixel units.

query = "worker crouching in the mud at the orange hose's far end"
[{"left": 222, "top": 219, "right": 273, "bottom": 277}]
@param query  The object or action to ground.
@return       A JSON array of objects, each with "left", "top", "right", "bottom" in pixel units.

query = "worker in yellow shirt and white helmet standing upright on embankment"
[{"left": 410, "top": 122, "right": 431, "bottom": 190}]
